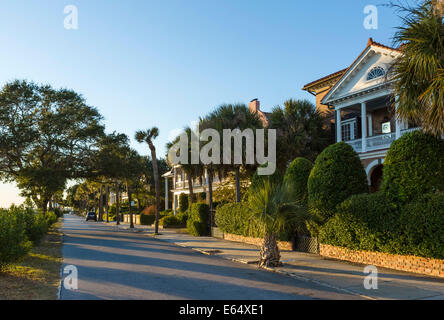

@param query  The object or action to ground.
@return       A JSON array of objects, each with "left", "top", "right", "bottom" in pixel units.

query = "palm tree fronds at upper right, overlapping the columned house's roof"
[{"left": 388, "top": 0, "right": 444, "bottom": 136}]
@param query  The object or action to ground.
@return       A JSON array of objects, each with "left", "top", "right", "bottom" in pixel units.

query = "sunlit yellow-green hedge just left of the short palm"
[{"left": 215, "top": 202, "right": 264, "bottom": 238}]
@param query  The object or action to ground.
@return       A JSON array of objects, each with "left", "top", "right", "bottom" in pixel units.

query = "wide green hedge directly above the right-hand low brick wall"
[{"left": 319, "top": 192, "right": 444, "bottom": 259}]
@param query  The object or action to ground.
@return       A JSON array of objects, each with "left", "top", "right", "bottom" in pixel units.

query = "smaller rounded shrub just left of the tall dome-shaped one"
[{"left": 284, "top": 158, "right": 313, "bottom": 204}]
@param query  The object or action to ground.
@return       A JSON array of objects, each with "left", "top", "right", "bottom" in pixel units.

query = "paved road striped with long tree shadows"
[{"left": 60, "top": 215, "right": 358, "bottom": 300}]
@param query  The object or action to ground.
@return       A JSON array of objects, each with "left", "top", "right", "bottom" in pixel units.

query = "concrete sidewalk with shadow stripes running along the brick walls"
[{"left": 100, "top": 223, "right": 444, "bottom": 300}]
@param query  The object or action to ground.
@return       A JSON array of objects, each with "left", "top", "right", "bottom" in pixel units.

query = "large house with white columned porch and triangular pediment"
[{"left": 304, "top": 38, "right": 417, "bottom": 191}]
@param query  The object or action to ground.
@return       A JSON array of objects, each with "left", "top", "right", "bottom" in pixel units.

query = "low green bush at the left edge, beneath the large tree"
[{"left": 0, "top": 210, "right": 32, "bottom": 271}]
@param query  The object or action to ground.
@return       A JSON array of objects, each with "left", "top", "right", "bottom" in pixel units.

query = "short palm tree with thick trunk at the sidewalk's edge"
[{"left": 248, "top": 178, "right": 307, "bottom": 267}]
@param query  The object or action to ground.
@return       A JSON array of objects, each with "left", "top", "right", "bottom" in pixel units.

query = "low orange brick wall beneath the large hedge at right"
[{"left": 320, "top": 244, "right": 444, "bottom": 278}]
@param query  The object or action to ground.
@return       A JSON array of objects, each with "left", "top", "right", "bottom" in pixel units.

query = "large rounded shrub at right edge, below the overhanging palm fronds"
[{"left": 381, "top": 131, "right": 444, "bottom": 202}]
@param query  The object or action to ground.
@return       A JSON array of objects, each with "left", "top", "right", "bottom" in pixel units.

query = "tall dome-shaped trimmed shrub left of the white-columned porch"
[{"left": 308, "top": 142, "right": 368, "bottom": 224}]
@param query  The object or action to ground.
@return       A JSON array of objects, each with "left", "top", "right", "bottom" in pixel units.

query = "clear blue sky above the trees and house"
[{"left": 0, "top": 0, "right": 399, "bottom": 206}]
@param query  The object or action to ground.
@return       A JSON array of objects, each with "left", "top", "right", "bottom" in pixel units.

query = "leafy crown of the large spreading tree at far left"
[{"left": 0, "top": 80, "right": 103, "bottom": 210}]
